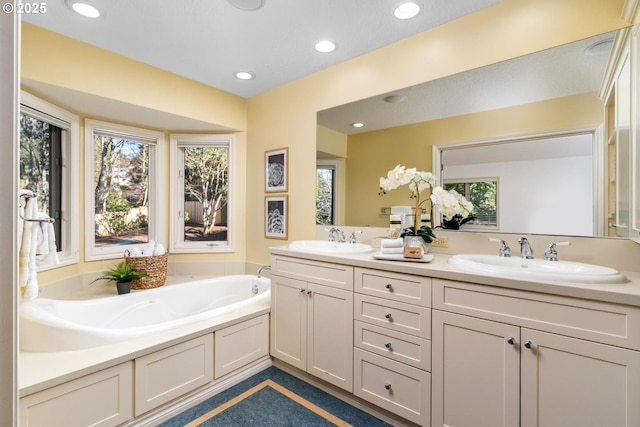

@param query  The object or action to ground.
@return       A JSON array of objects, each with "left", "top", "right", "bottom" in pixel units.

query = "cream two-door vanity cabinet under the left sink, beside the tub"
[{"left": 270, "top": 256, "right": 353, "bottom": 392}]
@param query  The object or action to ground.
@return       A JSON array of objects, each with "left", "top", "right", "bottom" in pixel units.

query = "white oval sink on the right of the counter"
[{"left": 449, "top": 254, "right": 627, "bottom": 283}]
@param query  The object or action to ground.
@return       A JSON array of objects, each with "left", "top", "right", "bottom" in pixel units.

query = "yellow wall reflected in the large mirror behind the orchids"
[{"left": 345, "top": 92, "right": 604, "bottom": 227}]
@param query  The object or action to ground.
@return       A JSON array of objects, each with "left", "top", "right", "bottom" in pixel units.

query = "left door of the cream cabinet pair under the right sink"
[{"left": 431, "top": 310, "right": 520, "bottom": 427}]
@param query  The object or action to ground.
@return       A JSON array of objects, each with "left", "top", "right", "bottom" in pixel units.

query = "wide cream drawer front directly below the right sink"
[{"left": 433, "top": 279, "right": 640, "bottom": 350}]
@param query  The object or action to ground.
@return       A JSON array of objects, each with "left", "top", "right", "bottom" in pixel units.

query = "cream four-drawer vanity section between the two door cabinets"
[{"left": 354, "top": 268, "right": 431, "bottom": 426}]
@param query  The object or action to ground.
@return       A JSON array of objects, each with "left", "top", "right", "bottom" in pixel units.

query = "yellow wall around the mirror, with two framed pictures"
[{"left": 247, "top": 0, "right": 628, "bottom": 262}]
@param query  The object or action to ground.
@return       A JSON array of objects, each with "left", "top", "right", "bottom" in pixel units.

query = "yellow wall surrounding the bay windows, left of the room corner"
[{"left": 21, "top": 23, "right": 247, "bottom": 284}]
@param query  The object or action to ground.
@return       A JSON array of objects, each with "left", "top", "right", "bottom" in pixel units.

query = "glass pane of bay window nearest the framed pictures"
[{"left": 183, "top": 145, "right": 229, "bottom": 242}]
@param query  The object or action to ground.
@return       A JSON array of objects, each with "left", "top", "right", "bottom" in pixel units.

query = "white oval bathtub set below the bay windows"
[{"left": 20, "top": 275, "right": 271, "bottom": 352}]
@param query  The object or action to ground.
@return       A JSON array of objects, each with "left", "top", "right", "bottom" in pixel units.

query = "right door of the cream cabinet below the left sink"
[{"left": 307, "top": 283, "right": 353, "bottom": 392}]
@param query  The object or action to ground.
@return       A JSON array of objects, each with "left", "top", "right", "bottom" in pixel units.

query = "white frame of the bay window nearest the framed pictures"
[{"left": 169, "top": 133, "right": 236, "bottom": 253}]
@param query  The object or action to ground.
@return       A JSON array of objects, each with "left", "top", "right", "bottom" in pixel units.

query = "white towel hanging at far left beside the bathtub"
[{"left": 19, "top": 197, "right": 38, "bottom": 299}]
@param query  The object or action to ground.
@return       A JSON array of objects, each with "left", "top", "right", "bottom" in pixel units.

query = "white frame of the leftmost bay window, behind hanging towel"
[{"left": 20, "top": 91, "right": 80, "bottom": 271}]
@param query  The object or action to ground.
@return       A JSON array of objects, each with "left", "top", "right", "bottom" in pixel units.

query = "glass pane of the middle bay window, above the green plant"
[{"left": 94, "top": 134, "right": 149, "bottom": 246}]
